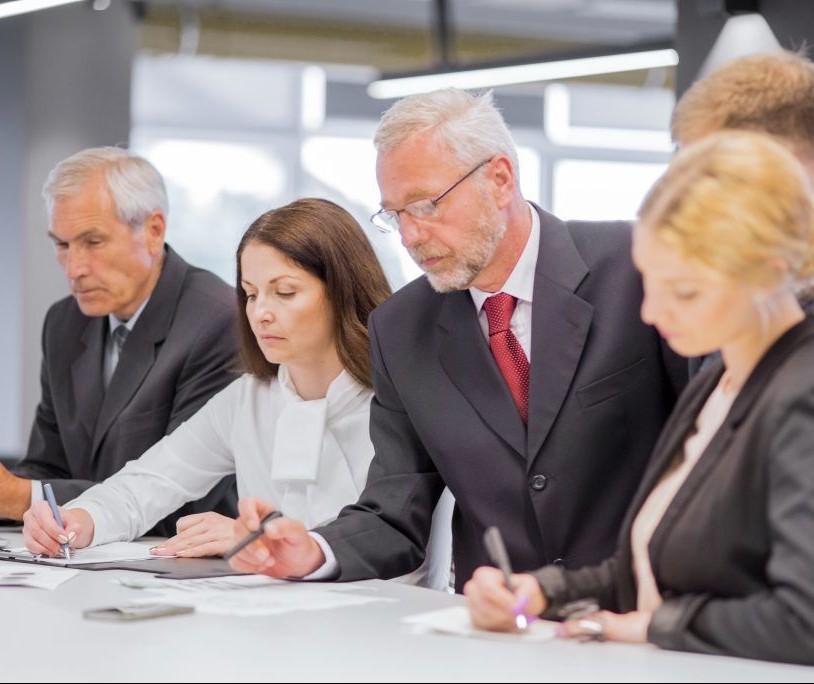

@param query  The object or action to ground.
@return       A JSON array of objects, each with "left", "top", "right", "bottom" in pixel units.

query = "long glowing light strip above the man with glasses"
[{"left": 367, "top": 48, "right": 678, "bottom": 100}]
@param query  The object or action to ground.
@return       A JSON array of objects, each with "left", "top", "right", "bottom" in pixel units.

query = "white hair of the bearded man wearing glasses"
[{"left": 373, "top": 88, "right": 519, "bottom": 174}]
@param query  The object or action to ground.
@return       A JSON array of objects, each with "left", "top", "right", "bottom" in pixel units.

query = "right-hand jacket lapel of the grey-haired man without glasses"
[{"left": 93, "top": 247, "right": 187, "bottom": 456}]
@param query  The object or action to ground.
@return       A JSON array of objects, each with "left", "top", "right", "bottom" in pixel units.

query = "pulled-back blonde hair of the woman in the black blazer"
[{"left": 637, "top": 131, "right": 814, "bottom": 290}]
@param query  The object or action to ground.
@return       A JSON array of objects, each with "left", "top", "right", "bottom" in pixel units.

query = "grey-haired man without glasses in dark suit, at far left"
[{"left": 0, "top": 147, "right": 237, "bottom": 535}]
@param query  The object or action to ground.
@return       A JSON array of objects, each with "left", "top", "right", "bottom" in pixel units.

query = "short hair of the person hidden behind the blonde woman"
[{"left": 671, "top": 51, "right": 814, "bottom": 157}]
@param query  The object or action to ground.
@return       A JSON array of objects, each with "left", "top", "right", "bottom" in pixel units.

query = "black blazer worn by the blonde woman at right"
[{"left": 537, "top": 317, "right": 814, "bottom": 664}]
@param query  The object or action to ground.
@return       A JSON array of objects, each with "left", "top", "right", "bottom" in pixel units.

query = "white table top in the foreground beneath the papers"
[{"left": 0, "top": 532, "right": 814, "bottom": 682}]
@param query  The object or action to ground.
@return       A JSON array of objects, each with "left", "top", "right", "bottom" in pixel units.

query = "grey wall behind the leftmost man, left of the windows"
[{"left": 0, "top": 3, "right": 136, "bottom": 455}]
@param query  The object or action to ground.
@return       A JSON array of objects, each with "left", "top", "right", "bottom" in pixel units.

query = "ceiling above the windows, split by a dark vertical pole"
[{"left": 141, "top": 0, "right": 677, "bottom": 80}]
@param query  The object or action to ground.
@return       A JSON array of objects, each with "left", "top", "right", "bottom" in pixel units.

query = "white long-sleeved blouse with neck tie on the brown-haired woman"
[{"left": 66, "top": 366, "right": 373, "bottom": 544}]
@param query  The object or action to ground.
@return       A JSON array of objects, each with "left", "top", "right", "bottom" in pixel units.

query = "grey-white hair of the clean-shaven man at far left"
[{"left": 42, "top": 147, "right": 169, "bottom": 230}]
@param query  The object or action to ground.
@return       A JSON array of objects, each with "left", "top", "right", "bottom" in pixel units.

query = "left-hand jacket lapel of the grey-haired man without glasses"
[{"left": 71, "top": 318, "right": 107, "bottom": 441}]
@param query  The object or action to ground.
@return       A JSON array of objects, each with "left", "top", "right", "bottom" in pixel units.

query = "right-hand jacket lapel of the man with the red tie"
[{"left": 528, "top": 208, "right": 593, "bottom": 462}]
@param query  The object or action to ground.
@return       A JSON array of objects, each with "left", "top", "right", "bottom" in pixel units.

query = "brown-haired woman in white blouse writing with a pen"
[{"left": 24, "top": 199, "right": 390, "bottom": 556}]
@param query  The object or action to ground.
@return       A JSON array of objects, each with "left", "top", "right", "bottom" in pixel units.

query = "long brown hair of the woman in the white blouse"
[{"left": 236, "top": 198, "right": 391, "bottom": 387}]
